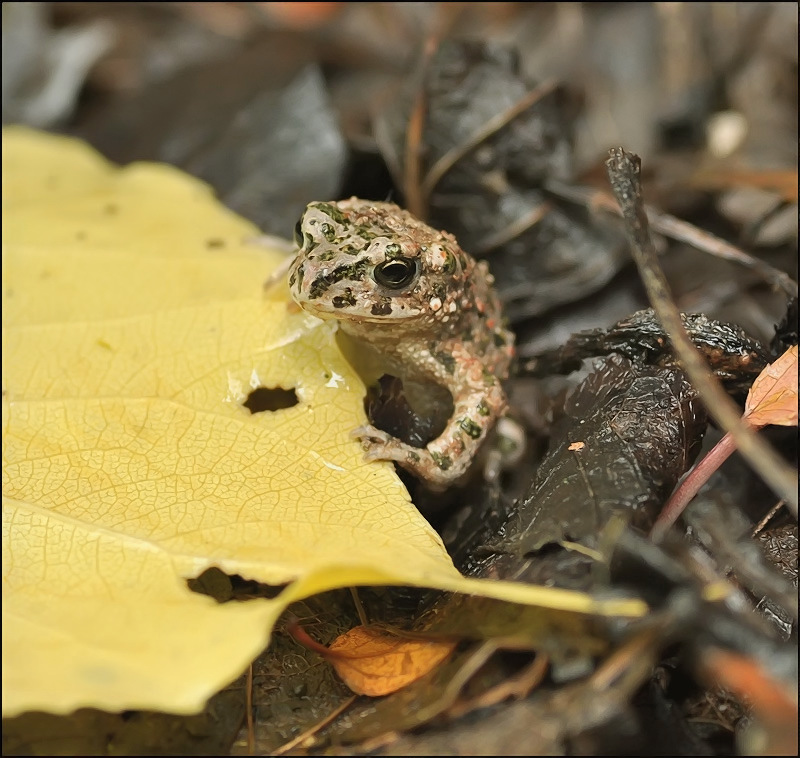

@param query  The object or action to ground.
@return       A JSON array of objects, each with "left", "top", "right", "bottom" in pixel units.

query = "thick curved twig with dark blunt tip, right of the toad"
[{"left": 606, "top": 148, "right": 797, "bottom": 528}]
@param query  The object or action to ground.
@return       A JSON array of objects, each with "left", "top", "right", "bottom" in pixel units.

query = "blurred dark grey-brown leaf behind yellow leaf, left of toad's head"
[{"left": 81, "top": 36, "right": 346, "bottom": 237}]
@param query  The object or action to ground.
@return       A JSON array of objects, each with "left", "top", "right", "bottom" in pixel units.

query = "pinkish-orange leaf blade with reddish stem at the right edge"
[{"left": 744, "top": 345, "right": 797, "bottom": 427}]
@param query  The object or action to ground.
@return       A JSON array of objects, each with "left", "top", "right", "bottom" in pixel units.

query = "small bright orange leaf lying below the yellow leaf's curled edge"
[{"left": 328, "top": 626, "right": 456, "bottom": 697}]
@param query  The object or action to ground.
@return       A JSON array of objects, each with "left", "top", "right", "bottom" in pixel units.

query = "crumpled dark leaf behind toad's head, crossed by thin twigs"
[{"left": 378, "top": 41, "right": 627, "bottom": 321}]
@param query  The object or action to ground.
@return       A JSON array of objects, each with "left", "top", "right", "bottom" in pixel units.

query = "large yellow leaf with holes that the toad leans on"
[{"left": 2, "top": 128, "right": 646, "bottom": 715}]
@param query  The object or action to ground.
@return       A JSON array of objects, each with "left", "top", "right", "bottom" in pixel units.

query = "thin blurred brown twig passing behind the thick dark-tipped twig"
[{"left": 545, "top": 179, "right": 798, "bottom": 297}]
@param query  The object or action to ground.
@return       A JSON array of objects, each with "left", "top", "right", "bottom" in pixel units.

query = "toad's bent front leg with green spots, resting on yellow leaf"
[{"left": 353, "top": 384, "right": 506, "bottom": 490}]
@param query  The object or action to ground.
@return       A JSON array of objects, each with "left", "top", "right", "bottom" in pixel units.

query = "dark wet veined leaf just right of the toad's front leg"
[{"left": 505, "top": 356, "right": 706, "bottom": 554}]
